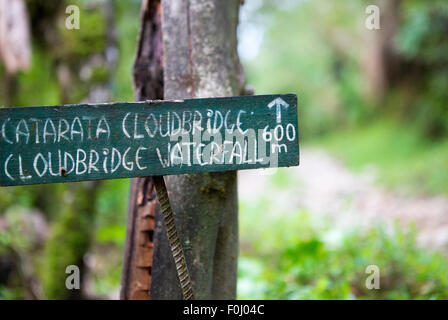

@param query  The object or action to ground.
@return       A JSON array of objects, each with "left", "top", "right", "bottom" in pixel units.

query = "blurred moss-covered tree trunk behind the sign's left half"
[{"left": 42, "top": 0, "right": 116, "bottom": 299}]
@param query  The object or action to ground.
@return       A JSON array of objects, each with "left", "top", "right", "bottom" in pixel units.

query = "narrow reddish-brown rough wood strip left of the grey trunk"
[{"left": 121, "top": 0, "right": 163, "bottom": 300}]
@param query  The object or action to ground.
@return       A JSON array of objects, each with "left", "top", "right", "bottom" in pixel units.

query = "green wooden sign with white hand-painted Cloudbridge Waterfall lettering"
[{"left": 0, "top": 94, "right": 299, "bottom": 186}]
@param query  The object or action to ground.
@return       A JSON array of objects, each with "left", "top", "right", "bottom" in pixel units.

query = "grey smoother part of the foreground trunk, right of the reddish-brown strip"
[{"left": 150, "top": 0, "right": 243, "bottom": 299}]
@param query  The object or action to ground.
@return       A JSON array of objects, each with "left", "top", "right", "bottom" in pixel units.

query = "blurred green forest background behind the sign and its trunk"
[{"left": 0, "top": 0, "right": 448, "bottom": 299}]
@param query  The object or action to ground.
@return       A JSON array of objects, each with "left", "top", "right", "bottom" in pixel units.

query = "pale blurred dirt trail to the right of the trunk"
[{"left": 239, "top": 148, "right": 448, "bottom": 249}]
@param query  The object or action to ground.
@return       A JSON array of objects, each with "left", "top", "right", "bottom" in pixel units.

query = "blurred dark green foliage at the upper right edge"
[{"left": 396, "top": 1, "right": 448, "bottom": 138}]
